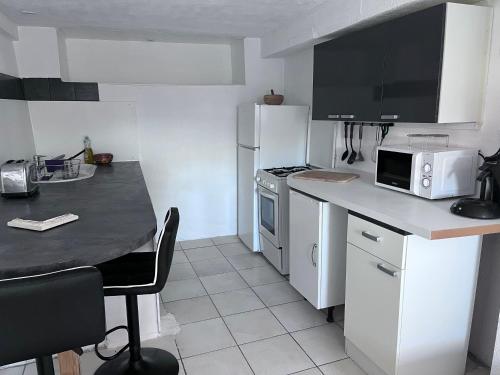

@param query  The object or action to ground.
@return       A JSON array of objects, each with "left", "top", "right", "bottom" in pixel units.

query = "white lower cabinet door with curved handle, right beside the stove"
[{"left": 290, "top": 191, "right": 321, "bottom": 307}]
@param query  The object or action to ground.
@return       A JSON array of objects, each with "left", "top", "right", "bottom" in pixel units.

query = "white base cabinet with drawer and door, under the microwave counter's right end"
[{"left": 344, "top": 215, "right": 482, "bottom": 375}]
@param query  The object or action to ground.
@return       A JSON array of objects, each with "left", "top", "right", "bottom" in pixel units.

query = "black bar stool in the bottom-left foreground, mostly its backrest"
[{"left": 0, "top": 267, "right": 106, "bottom": 375}]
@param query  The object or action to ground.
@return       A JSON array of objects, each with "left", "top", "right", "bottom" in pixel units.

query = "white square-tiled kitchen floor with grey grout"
[{"left": 0, "top": 236, "right": 488, "bottom": 375}]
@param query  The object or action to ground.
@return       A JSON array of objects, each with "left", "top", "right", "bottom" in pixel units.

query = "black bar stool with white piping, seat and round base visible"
[{"left": 96, "top": 207, "right": 179, "bottom": 375}]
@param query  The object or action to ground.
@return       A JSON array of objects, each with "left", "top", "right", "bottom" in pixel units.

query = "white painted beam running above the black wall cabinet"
[{"left": 261, "top": 0, "right": 477, "bottom": 57}]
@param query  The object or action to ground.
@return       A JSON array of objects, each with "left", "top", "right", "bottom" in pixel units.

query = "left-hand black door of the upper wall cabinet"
[{"left": 313, "top": 26, "right": 386, "bottom": 121}]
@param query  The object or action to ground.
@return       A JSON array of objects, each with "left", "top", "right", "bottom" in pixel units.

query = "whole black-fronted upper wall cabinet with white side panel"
[{"left": 312, "top": 3, "right": 491, "bottom": 123}]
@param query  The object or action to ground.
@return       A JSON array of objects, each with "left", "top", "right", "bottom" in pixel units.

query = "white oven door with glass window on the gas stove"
[{"left": 259, "top": 186, "right": 280, "bottom": 247}]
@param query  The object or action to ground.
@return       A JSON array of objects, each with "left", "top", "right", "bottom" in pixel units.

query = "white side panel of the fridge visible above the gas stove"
[{"left": 260, "top": 105, "right": 309, "bottom": 168}]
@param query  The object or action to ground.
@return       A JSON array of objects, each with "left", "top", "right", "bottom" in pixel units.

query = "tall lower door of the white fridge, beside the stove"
[{"left": 238, "top": 146, "right": 260, "bottom": 251}]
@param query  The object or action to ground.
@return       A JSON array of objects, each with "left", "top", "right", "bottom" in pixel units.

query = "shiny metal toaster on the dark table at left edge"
[{"left": 0, "top": 160, "right": 38, "bottom": 198}]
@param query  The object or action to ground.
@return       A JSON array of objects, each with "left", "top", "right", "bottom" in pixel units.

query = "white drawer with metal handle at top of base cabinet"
[{"left": 347, "top": 214, "right": 407, "bottom": 269}]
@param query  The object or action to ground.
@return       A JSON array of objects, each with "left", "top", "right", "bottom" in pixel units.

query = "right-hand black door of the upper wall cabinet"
[{"left": 380, "top": 4, "right": 446, "bottom": 123}]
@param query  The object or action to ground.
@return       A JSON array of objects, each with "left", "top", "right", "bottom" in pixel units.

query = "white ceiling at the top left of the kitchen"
[{"left": 0, "top": 0, "right": 329, "bottom": 38}]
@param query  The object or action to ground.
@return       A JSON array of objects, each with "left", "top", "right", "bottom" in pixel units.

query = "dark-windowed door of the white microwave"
[{"left": 375, "top": 149, "right": 415, "bottom": 193}]
